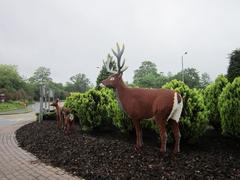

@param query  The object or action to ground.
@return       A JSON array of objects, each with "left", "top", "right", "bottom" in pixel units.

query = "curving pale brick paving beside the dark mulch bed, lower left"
[{"left": 0, "top": 112, "right": 79, "bottom": 180}]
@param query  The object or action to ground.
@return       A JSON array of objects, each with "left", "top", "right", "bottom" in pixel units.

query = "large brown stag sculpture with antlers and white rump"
[{"left": 101, "top": 44, "right": 183, "bottom": 153}]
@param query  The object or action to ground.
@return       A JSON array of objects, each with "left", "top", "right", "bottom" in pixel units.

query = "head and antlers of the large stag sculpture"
[{"left": 101, "top": 43, "right": 128, "bottom": 88}]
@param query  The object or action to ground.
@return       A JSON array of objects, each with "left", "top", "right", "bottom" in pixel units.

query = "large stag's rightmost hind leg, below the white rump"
[{"left": 169, "top": 119, "right": 181, "bottom": 154}]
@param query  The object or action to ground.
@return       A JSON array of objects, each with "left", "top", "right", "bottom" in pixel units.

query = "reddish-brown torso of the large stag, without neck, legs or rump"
[{"left": 116, "top": 81, "right": 178, "bottom": 119}]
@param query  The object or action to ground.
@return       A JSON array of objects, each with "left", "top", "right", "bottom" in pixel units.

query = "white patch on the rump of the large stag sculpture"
[{"left": 167, "top": 92, "right": 183, "bottom": 122}]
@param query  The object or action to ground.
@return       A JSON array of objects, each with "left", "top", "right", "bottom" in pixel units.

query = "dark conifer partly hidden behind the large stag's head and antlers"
[{"left": 96, "top": 54, "right": 116, "bottom": 87}]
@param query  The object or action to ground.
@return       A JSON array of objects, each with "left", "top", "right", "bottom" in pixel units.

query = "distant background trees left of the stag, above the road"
[{"left": 0, "top": 64, "right": 92, "bottom": 101}]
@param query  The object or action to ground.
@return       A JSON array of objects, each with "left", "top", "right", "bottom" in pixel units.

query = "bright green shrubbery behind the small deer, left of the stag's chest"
[{"left": 65, "top": 88, "right": 131, "bottom": 131}]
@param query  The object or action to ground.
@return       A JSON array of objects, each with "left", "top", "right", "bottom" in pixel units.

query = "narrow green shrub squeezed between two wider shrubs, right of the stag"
[{"left": 203, "top": 75, "right": 228, "bottom": 131}]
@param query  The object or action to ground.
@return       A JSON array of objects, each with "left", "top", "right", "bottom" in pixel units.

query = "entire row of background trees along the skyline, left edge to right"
[{"left": 0, "top": 49, "right": 240, "bottom": 100}]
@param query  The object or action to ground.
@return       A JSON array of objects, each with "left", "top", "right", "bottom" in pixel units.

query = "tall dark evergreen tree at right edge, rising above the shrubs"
[{"left": 227, "top": 49, "right": 240, "bottom": 82}]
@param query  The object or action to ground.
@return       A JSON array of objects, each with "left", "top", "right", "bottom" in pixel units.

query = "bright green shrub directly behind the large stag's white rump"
[{"left": 163, "top": 80, "right": 208, "bottom": 142}]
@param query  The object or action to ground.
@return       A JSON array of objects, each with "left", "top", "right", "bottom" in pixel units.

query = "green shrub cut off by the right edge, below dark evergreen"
[{"left": 218, "top": 77, "right": 240, "bottom": 137}]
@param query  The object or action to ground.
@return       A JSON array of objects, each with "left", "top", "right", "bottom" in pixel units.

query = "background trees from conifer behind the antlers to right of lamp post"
[{"left": 96, "top": 55, "right": 211, "bottom": 88}]
